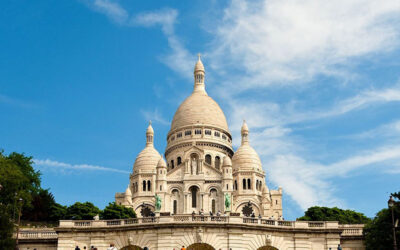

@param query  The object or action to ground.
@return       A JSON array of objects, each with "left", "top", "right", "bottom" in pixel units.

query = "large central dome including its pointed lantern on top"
[{"left": 170, "top": 57, "right": 229, "bottom": 132}]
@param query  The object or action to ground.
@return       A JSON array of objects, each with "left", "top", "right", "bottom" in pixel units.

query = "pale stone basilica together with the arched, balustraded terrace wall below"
[{"left": 18, "top": 57, "right": 365, "bottom": 250}]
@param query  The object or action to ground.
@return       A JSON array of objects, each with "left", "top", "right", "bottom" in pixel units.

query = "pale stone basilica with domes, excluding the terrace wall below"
[{"left": 115, "top": 56, "right": 282, "bottom": 219}]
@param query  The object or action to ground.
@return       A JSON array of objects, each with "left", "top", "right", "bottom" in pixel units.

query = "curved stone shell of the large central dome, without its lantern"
[{"left": 171, "top": 92, "right": 229, "bottom": 131}]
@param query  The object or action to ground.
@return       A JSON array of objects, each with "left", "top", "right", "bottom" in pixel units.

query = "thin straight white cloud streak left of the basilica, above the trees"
[{"left": 33, "top": 159, "right": 129, "bottom": 174}]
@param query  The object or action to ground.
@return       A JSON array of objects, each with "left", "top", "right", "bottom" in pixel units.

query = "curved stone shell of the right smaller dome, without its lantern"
[{"left": 232, "top": 144, "right": 262, "bottom": 170}]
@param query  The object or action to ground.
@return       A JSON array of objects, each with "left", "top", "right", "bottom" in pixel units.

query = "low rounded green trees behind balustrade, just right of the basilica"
[{"left": 297, "top": 206, "right": 370, "bottom": 224}]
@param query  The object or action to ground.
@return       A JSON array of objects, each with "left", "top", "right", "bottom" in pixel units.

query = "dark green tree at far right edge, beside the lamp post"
[{"left": 364, "top": 192, "right": 400, "bottom": 250}]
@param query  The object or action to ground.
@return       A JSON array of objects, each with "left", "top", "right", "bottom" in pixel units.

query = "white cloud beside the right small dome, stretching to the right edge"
[{"left": 262, "top": 145, "right": 400, "bottom": 209}]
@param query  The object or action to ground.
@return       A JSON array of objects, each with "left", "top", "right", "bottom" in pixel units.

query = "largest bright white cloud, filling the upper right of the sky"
[{"left": 208, "top": 0, "right": 400, "bottom": 89}]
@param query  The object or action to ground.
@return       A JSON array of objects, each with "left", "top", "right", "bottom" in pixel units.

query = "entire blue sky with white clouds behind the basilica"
[{"left": 0, "top": 0, "right": 400, "bottom": 219}]
